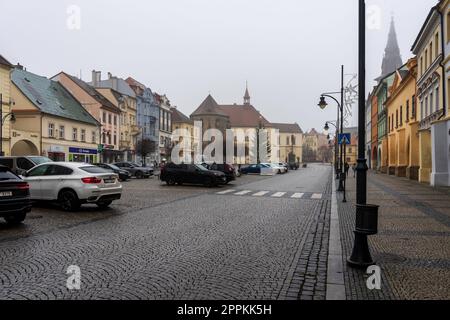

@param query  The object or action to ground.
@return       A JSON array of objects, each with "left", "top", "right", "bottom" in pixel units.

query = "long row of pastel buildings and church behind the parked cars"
[{"left": 0, "top": 55, "right": 320, "bottom": 164}]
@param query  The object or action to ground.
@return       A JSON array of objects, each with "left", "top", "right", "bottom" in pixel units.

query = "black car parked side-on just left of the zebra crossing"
[{"left": 160, "top": 163, "right": 227, "bottom": 187}]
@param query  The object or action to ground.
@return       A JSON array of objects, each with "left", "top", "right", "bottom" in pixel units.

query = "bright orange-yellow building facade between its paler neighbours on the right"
[{"left": 386, "top": 58, "right": 420, "bottom": 180}]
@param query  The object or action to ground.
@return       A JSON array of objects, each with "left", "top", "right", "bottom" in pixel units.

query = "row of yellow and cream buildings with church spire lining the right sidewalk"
[{"left": 366, "top": 0, "right": 450, "bottom": 186}]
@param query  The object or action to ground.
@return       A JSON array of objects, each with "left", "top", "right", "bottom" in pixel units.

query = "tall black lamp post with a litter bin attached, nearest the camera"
[{"left": 347, "top": 0, "right": 378, "bottom": 269}]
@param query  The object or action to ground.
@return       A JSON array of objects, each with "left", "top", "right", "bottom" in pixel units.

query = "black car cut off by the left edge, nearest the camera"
[{"left": 0, "top": 166, "right": 31, "bottom": 225}]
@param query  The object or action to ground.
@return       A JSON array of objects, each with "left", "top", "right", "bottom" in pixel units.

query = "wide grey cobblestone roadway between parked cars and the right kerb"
[{"left": 0, "top": 165, "right": 331, "bottom": 299}]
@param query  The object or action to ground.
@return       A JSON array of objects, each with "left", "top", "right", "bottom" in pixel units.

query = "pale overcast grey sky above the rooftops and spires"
[{"left": 0, "top": 0, "right": 437, "bottom": 130}]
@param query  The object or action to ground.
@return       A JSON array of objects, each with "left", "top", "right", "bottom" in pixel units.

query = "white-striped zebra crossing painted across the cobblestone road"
[{"left": 216, "top": 189, "right": 324, "bottom": 200}]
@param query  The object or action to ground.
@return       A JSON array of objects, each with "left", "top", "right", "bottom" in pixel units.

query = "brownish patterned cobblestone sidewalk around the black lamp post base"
[{"left": 338, "top": 172, "right": 450, "bottom": 300}]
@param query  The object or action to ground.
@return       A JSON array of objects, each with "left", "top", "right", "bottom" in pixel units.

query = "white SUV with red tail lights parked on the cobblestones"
[{"left": 24, "top": 162, "right": 122, "bottom": 211}]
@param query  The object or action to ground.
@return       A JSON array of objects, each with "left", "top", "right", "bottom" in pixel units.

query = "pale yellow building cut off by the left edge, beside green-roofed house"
[{"left": 0, "top": 55, "right": 13, "bottom": 156}]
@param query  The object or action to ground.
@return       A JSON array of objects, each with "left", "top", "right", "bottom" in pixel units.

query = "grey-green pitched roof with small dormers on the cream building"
[{"left": 11, "top": 69, "right": 99, "bottom": 125}]
